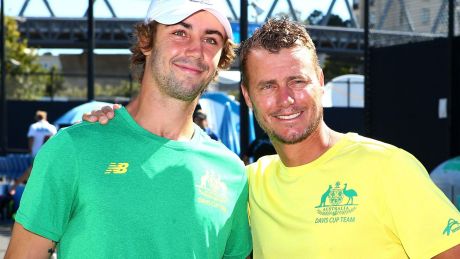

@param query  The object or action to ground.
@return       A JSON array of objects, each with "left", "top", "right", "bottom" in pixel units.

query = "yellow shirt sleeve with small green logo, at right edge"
[{"left": 383, "top": 150, "right": 460, "bottom": 258}]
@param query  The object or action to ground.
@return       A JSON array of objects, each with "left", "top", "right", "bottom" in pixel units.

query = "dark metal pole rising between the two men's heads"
[{"left": 240, "top": 0, "right": 249, "bottom": 157}]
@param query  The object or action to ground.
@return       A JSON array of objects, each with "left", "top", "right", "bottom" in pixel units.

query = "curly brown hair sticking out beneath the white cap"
[{"left": 130, "top": 21, "right": 236, "bottom": 82}]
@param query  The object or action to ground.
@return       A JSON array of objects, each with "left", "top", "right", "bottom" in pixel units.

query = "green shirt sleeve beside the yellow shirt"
[{"left": 223, "top": 179, "right": 252, "bottom": 259}]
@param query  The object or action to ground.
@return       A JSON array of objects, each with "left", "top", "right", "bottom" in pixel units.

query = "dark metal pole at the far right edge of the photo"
[{"left": 447, "top": 0, "right": 460, "bottom": 157}]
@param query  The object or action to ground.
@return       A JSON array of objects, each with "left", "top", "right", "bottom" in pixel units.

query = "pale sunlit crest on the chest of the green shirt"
[{"left": 195, "top": 171, "right": 228, "bottom": 213}]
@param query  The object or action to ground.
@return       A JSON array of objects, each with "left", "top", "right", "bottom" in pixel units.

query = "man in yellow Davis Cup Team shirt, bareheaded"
[{"left": 87, "top": 19, "right": 460, "bottom": 259}]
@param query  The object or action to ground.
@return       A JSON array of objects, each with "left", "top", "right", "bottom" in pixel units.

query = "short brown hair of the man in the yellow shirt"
[{"left": 237, "top": 18, "right": 320, "bottom": 87}]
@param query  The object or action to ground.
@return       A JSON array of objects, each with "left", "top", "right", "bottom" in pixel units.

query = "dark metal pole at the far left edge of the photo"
[{"left": 0, "top": 0, "right": 8, "bottom": 155}]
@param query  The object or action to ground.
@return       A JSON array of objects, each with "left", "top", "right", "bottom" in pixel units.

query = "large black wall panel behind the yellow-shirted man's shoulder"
[{"left": 369, "top": 36, "right": 460, "bottom": 171}]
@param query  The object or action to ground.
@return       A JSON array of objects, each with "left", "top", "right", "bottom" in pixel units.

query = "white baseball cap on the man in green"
[{"left": 144, "top": 0, "right": 233, "bottom": 40}]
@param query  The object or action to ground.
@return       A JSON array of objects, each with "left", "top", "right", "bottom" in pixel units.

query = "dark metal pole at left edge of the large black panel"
[{"left": 364, "top": 0, "right": 372, "bottom": 137}]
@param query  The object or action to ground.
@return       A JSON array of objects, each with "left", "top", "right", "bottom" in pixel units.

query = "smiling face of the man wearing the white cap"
[{"left": 144, "top": 11, "right": 226, "bottom": 101}]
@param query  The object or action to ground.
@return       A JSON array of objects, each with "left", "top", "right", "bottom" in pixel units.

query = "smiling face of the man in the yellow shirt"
[{"left": 242, "top": 45, "right": 324, "bottom": 144}]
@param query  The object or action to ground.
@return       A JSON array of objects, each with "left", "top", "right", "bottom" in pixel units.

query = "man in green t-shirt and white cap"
[{"left": 5, "top": 0, "right": 252, "bottom": 259}]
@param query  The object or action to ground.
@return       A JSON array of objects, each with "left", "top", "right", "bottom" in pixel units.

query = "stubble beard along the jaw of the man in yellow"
[{"left": 253, "top": 103, "right": 323, "bottom": 145}]
